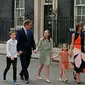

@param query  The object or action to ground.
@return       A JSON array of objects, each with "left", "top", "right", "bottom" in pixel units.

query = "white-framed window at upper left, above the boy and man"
[{"left": 15, "top": 0, "right": 25, "bottom": 25}]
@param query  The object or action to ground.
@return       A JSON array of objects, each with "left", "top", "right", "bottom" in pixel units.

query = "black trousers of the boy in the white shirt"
[{"left": 3, "top": 57, "right": 17, "bottom": 80}]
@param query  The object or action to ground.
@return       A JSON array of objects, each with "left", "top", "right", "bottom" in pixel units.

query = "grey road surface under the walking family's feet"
[{"left": 0, "top": 55, "right": 85, "bottom": 85}]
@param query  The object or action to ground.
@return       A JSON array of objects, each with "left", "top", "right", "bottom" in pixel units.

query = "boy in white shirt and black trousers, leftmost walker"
[{"left": 3, "top": 31, "right": 18, "bottom": 85}]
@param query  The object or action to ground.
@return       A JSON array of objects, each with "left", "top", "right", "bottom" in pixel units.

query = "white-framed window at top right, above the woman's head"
[{"left": 74, "top": 0, "right": 85, "bottom": 24}]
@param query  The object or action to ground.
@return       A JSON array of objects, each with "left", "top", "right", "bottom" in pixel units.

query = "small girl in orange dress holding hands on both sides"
[{"left": 56, "top": 44, "right": 73, "bottom": 83}]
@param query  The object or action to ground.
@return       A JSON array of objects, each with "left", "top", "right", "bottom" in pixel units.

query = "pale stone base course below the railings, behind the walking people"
[{"left": 0, "top": 44, "right": 73, "bottom": 62}]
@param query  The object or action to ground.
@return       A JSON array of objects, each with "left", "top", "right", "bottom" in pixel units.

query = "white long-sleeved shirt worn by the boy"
[{"left": 7, "top": 39, "right": 18, "bottom": 58}]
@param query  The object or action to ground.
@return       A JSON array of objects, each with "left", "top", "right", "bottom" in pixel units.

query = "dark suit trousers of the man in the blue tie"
[{"left": 20, "top": 54, "right": 31, "bottom": 81}]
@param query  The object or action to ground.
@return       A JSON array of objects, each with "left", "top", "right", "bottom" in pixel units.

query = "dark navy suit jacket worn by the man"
[{"left": 16, "top": 28, "right": 36, "bottom": 54}]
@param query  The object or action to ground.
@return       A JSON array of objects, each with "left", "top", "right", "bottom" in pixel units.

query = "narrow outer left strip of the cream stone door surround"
[{"left": 34, "top": 0, "right": 38, "bottom": 44}]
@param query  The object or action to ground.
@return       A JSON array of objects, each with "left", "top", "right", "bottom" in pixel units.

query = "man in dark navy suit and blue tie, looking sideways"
[{"left": 17, "top": 20, "right": 36, "bottom": 84}]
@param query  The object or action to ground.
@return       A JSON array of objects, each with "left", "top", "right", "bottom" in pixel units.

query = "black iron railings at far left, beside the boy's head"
[{"left": 0, "top": 19, "right": 14, "bottom": 43}]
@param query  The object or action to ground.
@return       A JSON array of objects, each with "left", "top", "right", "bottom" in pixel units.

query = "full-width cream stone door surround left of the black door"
[{"left": 34, "top": 0, "right": 45, "bottom": 44}]
